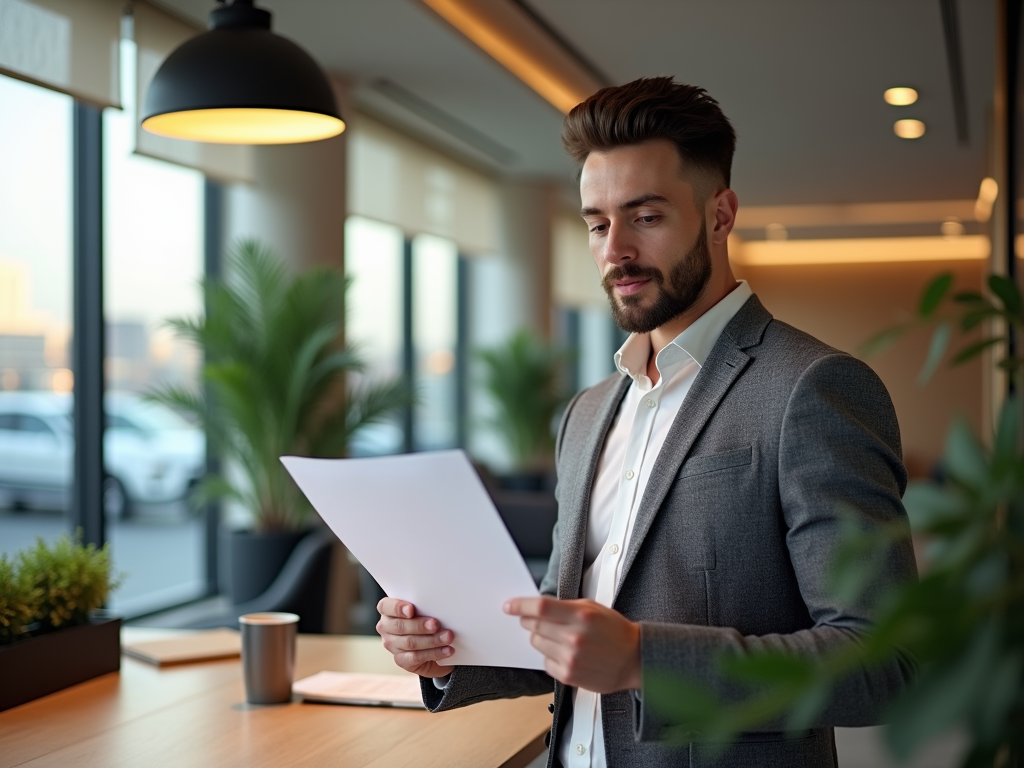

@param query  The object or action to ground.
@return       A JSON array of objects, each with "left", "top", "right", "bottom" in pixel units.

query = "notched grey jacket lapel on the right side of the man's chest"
[{"left": 612, "top": 296, "right": 771, "bottom": 604}]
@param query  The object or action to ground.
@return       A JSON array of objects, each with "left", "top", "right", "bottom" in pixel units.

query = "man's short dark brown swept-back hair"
[{"left": 562, "top": 77, "right": 736, "bottom": 192}]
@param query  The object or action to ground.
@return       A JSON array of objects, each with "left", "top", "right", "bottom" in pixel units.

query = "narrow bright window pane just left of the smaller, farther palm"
[{"left": 413, "top": 234, "right": 459, "bottom": 451}]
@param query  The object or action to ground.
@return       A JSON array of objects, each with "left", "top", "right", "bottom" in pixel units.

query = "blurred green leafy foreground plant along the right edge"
[{"left": 645, "top": 273, "right": 1024, "bottom": 768}]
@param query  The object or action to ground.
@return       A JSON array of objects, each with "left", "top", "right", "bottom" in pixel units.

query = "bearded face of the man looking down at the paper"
[{"left": 580, "top": 139, "right": 712, "bottom": 333}]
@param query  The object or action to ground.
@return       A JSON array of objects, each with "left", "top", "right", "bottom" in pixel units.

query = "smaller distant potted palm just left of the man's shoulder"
[{"left": 477, "top": 330, "right": 568, "bottom": 490}]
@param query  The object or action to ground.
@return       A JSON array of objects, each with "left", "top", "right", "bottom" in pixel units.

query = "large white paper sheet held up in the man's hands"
[{"left": 281, "top": 451, "right": 544, "bottom": 670}]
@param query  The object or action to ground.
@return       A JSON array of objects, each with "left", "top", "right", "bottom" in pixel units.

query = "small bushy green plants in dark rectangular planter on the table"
[{"left": 0, "top": 534, "right": 121, "bottom": 712}]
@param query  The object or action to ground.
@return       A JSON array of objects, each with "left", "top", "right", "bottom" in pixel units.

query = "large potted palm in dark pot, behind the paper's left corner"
[{"left": 151, "top": 241, "right": 409, "bottom": 604}]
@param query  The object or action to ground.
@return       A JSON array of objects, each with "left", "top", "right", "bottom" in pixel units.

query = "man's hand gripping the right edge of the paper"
[{"left": 505, "top": 597, "right": 640, "bottom": 693}]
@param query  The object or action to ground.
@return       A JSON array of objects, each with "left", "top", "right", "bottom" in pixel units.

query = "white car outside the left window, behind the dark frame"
[{"left": 0, "top": 392, "right": 206, "bottom": 519}]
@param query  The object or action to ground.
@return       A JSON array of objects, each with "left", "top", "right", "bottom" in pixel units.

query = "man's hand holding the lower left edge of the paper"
[{"left": 377, "top": 597, "right": 455, "bottom": 677}]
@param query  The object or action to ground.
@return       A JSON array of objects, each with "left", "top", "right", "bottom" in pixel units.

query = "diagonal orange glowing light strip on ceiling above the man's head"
[{"left": 415, "top": 0, "right": 590, "bottom": 114}]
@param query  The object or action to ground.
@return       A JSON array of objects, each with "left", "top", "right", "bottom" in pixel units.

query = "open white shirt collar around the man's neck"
[{"left": 614, "top": 280, "right": 753, "bottom": 381}]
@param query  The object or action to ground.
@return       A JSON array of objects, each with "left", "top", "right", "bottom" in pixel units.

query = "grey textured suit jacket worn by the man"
[{"left": 422, "top": 296, "right": 916, "bottom": 768}]
